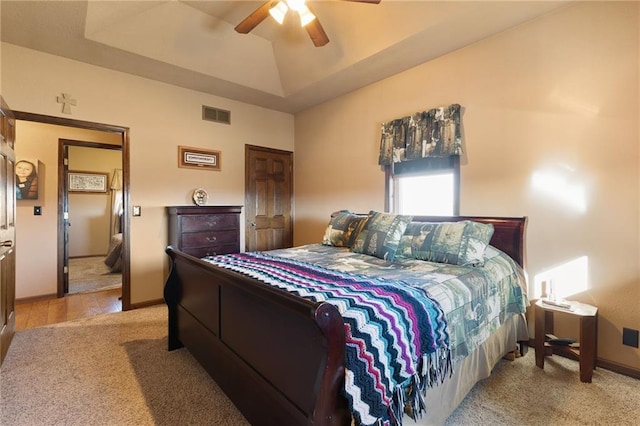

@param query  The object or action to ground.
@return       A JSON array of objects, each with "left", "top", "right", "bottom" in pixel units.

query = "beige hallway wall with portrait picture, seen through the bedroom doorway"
[{"left": 16, "top": 121, "right": 120, "bottom": 299}]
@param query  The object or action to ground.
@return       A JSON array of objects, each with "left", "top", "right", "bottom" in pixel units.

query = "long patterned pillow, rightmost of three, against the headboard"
[{"left": 397, "top": 220, "right": 493, "bottom": 266}]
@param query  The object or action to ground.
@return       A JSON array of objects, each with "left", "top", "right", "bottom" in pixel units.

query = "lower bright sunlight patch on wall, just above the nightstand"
[{"left": 534, "top": 256, "right": 589, "bottom": 299}]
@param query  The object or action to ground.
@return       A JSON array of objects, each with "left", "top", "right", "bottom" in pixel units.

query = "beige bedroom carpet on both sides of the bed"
[{"left": 0, "top": 306, "right": 640, "bottom": 426}]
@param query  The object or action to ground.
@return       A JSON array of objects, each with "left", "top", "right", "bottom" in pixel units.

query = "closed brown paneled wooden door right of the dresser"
[{"left": 245, "top": 145, "right": 293, "bottom": 251}]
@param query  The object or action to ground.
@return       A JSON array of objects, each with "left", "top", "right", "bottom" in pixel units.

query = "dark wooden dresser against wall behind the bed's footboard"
[{"left": 167, "top": 206, "right": 242, "bottom": 258}]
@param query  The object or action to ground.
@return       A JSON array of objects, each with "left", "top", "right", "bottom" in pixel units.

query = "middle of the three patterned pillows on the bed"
[{"left": 351, "top": 211, "right": 413, "bottom": 260}]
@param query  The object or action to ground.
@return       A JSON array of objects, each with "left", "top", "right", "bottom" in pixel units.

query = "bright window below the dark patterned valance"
[{"left": 386, "top": 156, "right": 460, "bottom": 216}]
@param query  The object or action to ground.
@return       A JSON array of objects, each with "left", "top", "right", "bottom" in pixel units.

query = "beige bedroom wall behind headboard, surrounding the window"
[{"left": 294, "top": 2, "right": 640, "bottom": 369}]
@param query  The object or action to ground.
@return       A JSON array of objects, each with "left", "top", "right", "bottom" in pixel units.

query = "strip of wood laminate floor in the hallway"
[{"left": 16, "top": 288, "right": 122, "bottom": 331}]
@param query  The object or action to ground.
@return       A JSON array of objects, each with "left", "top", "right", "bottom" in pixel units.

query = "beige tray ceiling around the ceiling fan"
[{"left": 1, "top": 0, "right": 567, "bottom": 113}]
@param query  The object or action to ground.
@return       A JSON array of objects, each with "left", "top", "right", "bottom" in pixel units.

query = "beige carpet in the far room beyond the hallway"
[{"left": 69, "top": 256, "right": 122, "bottom": 294}]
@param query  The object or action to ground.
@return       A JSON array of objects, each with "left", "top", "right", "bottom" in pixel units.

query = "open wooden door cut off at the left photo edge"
[{"left": 0, "top": 97, "right": 16, "bottom": 365}]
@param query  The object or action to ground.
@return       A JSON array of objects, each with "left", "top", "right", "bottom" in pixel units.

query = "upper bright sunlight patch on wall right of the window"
[{"left": 531, "top": 165, "right": 587, "bottom": 213}]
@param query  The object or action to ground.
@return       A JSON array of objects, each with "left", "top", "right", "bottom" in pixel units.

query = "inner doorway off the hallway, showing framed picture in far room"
[{"left": 58, "top": 139, "right": 124, "bottom": 294}]
